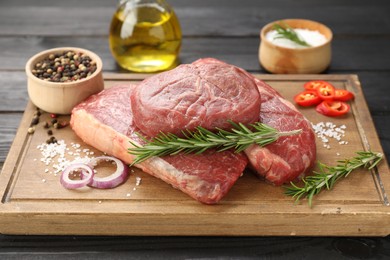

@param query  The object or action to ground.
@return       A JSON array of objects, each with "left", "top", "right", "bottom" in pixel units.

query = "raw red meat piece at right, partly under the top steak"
[{"left": 194, "top": 58, "right": 316, "bottom": 185}]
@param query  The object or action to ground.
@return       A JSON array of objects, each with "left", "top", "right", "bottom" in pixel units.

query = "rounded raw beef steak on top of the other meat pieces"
[{"left": 131, "top": 60, "right": 260, "bottom": 136}]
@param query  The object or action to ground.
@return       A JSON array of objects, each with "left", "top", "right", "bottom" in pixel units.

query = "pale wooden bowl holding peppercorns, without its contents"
[{"left": 25, "top": 47, "right": 104, "bottom": 114}]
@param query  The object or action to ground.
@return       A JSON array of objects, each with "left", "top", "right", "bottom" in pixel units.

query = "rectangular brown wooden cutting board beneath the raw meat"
[{"left": 0, "top": 74, "right": 390, "bottom": 236}]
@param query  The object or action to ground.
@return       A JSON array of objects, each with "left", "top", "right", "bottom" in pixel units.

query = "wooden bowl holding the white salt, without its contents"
[{"left": 259, "top": 19, "right": 333, "bottom": 74}]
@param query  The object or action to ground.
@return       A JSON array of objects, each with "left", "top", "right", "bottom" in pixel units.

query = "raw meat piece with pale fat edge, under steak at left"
[{"left": 70, "top": 85, "right": 248, "bottom": 204}]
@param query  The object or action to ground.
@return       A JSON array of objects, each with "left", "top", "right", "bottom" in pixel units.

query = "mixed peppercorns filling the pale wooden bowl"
[{"left": 31, "top": 50, "right": 96, "bottom": 82}]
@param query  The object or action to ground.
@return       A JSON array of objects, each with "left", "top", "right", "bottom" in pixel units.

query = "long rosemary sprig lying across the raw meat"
[{"left": 128, "top": 121, "right": 302, "bottom": 165}]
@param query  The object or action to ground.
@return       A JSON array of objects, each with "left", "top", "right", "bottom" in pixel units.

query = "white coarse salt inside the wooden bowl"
[{"left": 265, "top": 28, "right": 326, "bottom": 49}]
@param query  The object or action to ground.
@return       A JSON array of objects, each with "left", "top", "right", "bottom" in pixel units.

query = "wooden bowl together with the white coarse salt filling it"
[{"left": 259, "top": 19, "right": 333, "bottom": 74}]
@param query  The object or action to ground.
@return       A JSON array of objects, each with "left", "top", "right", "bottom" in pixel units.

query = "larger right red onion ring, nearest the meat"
[{"left": 82, "top": 156, "right": 129, "bottom": 189}]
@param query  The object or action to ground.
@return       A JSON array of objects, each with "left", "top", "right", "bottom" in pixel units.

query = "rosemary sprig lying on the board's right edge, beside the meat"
[{"left": 285, "top": 151, "right": 383, "bottom": 207}]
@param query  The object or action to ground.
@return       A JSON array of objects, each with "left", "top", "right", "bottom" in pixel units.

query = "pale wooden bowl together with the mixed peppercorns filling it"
[{"left": 26, "top": 47, "right": 104, "bottom": 114}]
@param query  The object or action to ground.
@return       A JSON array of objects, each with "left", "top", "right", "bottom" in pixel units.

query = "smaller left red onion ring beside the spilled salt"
[{"left": 60, "top": 163, "right": 94, "bottom": 189}]
